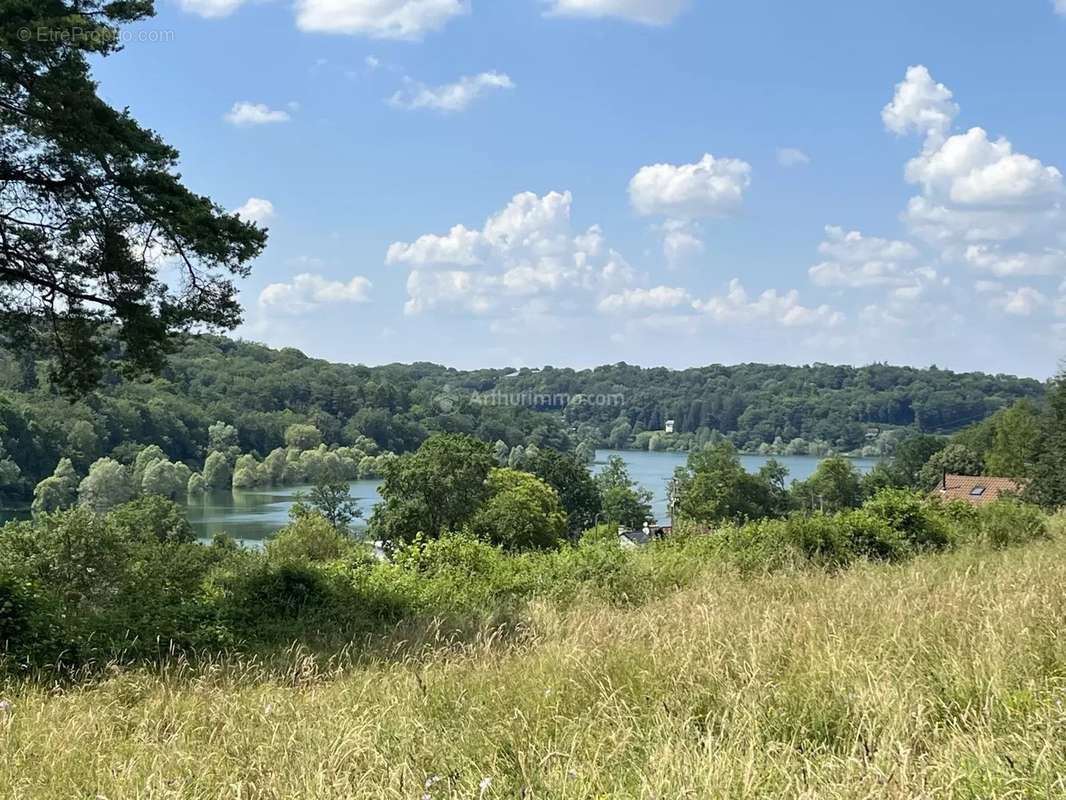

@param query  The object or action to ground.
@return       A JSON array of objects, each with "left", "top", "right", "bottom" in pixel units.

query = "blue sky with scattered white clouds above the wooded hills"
[{"left": 96, "top": 0, "right": 1066, "bottom": 378}]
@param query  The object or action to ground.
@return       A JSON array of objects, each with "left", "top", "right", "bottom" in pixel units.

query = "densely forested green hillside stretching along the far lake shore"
[{"left": 0, "top": 336, "right": 1045, "bottom": 498}]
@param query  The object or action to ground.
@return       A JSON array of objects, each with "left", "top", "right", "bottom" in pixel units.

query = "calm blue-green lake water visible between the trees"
[{"left": 0, "top": 450, "right": 877, "bottom": 545}]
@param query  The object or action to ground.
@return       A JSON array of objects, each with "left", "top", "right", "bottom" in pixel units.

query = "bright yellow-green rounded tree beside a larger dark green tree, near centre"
[{"left": 470, "top": 468, "right": 566, "bottom": 550}]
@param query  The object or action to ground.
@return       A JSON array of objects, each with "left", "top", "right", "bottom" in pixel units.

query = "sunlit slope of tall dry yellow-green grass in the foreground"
[{"left": 0, "top": 538, "right": 1066, "bottom": 800}]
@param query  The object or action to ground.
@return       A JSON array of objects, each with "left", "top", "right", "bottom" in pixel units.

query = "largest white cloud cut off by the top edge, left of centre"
[{"left": 296, "top": 0, "right": 470, "bottom": 41}]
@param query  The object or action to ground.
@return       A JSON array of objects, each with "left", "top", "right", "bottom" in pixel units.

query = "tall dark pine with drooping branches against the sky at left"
[{"left": 0, "top": 0, "right": 267, "bottom": 393}]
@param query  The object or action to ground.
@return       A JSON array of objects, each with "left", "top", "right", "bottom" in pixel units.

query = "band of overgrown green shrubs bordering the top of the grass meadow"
[{"left": 0, "top": 468, "right": 1048, "bottom": 672}]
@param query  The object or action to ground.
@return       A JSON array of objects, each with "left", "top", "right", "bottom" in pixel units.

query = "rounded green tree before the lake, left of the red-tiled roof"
[{"left": 676, "top": 442, "right": 784, "bottom": 524}]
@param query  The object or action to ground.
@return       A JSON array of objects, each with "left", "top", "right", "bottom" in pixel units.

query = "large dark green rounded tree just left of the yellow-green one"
[{"left": 370, "top": 433, "right": 496, "bottom": 542}]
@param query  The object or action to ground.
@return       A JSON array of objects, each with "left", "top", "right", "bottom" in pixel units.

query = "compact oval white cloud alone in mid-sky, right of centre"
[{"left": 629, "top": 154, "right": 752, "bottom": 220}]
